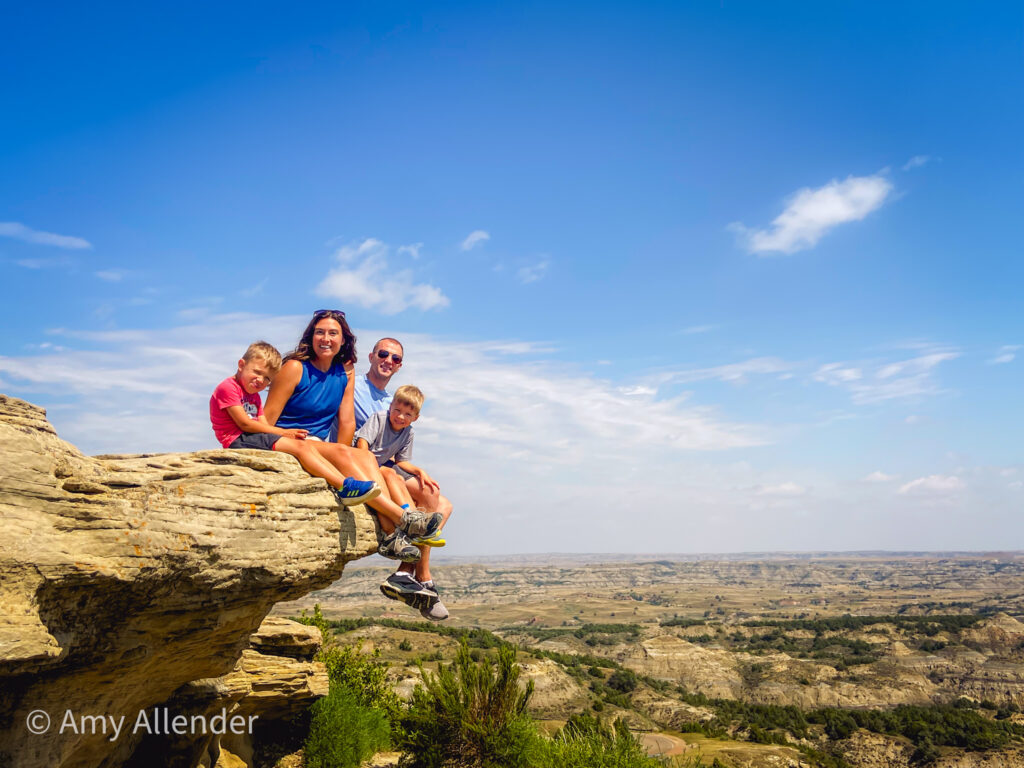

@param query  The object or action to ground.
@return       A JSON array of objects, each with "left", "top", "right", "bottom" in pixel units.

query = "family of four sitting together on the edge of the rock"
[{"left": 210, "top": 309, "right": 452, "bottom": 621}]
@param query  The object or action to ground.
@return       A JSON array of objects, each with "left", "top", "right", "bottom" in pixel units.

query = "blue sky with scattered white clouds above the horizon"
[{"left": 0, "top": 2, "right": 1024, "bottom": 554}]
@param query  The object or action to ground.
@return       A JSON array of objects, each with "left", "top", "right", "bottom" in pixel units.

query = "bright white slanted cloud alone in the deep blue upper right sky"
[{"left": 730, "top": 174, "right": 893, "bottom": 253}]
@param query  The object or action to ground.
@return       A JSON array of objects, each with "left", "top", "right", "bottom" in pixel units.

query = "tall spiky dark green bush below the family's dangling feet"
[{"left": 401, "top": 642, "right": 543, "bottom": 768}]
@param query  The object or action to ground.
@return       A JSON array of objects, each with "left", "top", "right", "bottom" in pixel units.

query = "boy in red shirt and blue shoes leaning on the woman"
[{"left": 210, "top": 341, "right": 381, "bottom": 505}]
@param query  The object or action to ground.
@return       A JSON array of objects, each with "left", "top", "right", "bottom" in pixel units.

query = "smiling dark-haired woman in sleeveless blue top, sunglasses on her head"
[{"left": 263, "top": 309, "right": 440, "bottom": 562}]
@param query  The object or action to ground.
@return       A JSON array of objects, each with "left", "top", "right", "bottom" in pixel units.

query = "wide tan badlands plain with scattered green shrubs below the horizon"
[{"left": 274, "top": 552, "right": 1024, "bottom": 768}]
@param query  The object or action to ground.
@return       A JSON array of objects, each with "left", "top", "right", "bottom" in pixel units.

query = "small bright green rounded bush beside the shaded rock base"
[{"left": 305, "top": 684, "right": 391, "bottom": 768}]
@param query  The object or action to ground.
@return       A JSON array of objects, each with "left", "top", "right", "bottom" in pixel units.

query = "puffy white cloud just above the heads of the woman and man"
[{"left": 316, "top": 238, "right": 451, "bottom": 314}]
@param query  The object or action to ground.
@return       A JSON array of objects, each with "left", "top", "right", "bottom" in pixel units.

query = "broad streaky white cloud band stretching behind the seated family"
[{"left": 0, "top": 313, "right": 766, "bottom": 462}]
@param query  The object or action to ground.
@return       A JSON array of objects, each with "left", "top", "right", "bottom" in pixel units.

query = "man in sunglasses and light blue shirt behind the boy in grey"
[{"left": 353, "top": 338, "right": 452, "bottom": 621}]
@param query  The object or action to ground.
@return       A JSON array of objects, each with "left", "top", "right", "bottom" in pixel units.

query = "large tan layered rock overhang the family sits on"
[{"left": 0, "top": 395, "right": 377, "bottom": 768}]
